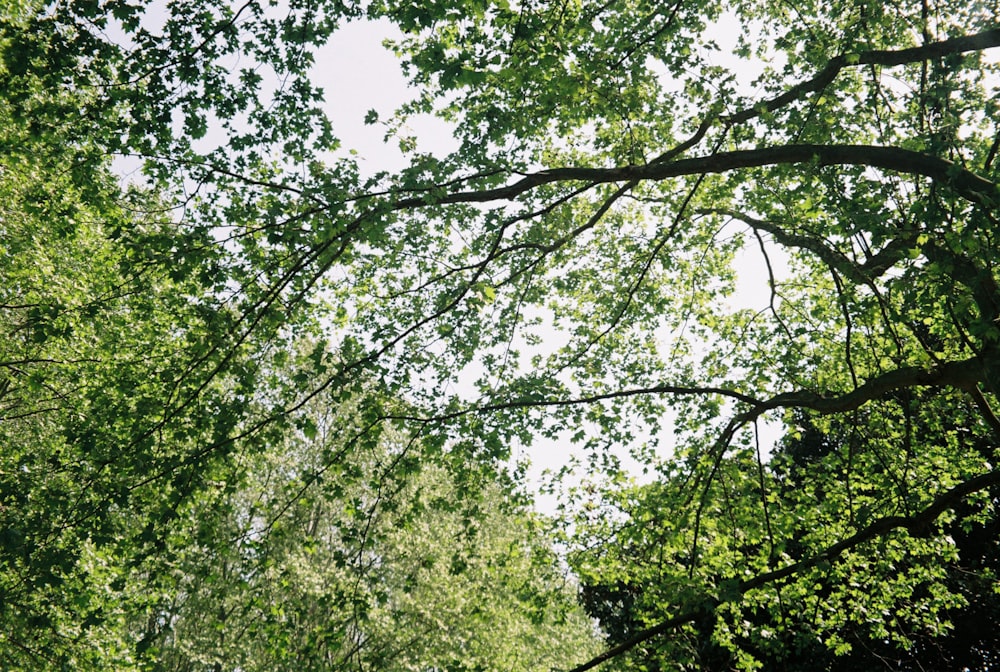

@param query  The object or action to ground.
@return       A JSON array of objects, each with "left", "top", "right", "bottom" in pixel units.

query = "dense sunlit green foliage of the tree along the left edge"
[{"left": 0, "top": 65, "right": 254, "bottom": 669}]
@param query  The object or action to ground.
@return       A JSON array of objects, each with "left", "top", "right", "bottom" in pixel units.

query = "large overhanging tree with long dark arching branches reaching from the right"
[{"left": 0, "top": 0, "right": 1000, "bottom": 670}]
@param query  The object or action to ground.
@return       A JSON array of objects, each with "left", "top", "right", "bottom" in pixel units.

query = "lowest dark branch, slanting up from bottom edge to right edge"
[{"left": 570, "top": 470, "right": 1000, "bottom": 672}]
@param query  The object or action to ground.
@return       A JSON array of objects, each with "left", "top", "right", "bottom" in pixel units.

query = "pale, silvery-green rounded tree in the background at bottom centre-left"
[{"left": 132, "top": 378, "right": 595, "bottom": 671}]
